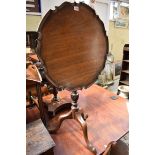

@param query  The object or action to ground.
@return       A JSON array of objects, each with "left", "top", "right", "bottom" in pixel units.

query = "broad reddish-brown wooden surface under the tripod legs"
[{"left": 27, "top": 85, "right": 128, "bottom": 155}]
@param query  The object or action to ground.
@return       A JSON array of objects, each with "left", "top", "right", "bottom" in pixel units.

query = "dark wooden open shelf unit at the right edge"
[{"left": 119, "top": 44, "right": 129, "bottom": 86}]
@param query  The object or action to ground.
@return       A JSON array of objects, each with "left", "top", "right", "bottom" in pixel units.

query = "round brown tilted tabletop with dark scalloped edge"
[{"left": 37, "top": 2, "right": 108, "bottom": 90}]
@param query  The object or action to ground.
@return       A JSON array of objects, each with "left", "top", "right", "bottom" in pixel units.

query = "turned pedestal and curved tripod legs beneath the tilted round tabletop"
[{"left": 48, "top": 91, "right": 97, "bottom": 154}]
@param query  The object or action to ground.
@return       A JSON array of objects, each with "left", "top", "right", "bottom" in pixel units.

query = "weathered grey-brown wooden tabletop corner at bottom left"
[{"left": 26, "top": 119, "right": 55, "bottom": 155}]
